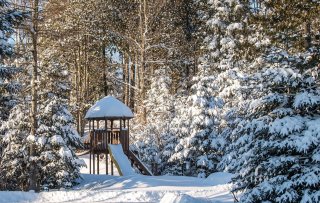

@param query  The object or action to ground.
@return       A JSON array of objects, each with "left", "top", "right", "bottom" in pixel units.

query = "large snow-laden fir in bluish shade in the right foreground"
[{"left": 224, "top": 49, "right": 320, "bottom": 202}]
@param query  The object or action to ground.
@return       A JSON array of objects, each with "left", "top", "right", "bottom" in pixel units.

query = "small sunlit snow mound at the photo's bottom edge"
[{"left": 160, "top": 193, "right": 209, "bottom": 203}]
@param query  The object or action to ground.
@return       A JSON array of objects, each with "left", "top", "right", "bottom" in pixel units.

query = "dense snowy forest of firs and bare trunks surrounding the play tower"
[{"left": 0, "top": 0, "right": 320, "bottom": 202}]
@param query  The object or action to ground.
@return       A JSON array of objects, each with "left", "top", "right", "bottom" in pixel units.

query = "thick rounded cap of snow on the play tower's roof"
[{"left": 85, "top": 96, "right": 133, "bottom": 119}]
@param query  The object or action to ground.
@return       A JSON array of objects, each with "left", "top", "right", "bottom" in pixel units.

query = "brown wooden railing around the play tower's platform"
[{"left": 87, "top": 129, "right": 129, "bottom": 153}]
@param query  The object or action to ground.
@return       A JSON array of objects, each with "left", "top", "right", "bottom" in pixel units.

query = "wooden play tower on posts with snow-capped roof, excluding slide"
[{"left": 85, "top": 96, "right": 152, "bottom": 175}]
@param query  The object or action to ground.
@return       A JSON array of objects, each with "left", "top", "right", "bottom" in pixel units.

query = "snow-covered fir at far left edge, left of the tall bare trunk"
[{"left": 0, "top": 104, "right": 30, "bottom": 190}]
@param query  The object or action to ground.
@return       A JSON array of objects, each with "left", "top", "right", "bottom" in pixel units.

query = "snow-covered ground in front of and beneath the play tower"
[{"left": 0, "top": 156, "right": 233, "bottom": 203}]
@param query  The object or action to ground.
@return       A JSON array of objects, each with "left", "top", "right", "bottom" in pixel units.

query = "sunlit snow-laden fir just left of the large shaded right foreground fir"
[{"left": 170, "top": 77, "right": 224, "bottom": 177}]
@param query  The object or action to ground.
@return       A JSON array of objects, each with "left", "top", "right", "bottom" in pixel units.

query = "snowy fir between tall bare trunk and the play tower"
[{"left": 37, "top": 96, "right": 84, "bottom": 188}]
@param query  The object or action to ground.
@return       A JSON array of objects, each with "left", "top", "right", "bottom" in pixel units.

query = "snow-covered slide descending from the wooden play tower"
[{"left": 108, "top": 144, "right": 136, "bottom": 176}]
